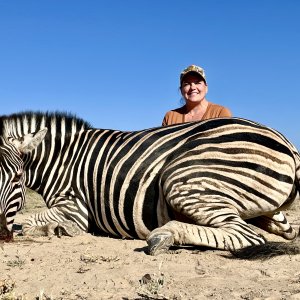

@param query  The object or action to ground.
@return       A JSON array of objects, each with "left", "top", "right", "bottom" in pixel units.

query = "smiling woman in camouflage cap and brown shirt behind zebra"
[{"left": 162, "top": 65, "right": 232, "bottom": 126}]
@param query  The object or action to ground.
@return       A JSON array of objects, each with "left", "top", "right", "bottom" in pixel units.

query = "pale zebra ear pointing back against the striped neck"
[{"left": 13, "top": 127, "right": 48, "bottom": 153}]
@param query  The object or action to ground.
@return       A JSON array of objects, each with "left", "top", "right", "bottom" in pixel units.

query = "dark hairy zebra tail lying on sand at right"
[{"left": 230, "top": 238, "right": 300, "bottom": 260}]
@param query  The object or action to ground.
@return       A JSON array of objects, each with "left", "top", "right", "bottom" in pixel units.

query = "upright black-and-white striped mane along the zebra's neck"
[{"left": 0, "top": 111, "right": 92, "bottom": 137}]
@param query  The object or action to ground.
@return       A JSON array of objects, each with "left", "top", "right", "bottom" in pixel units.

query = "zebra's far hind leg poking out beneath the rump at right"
[{"left": 247, "top": 211, "right": 298, "bottom": 240}]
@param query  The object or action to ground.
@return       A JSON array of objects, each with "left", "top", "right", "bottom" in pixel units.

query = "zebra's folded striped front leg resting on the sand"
[{"left": 23, "top": 207, "right": 87, "bottom": 236}]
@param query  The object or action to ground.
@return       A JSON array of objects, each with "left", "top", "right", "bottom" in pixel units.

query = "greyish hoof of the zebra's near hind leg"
[{"left": 147, "top": 233, "right": 174, "bottom": 256}]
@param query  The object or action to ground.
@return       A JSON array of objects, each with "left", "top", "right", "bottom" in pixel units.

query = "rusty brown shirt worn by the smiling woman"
[{"left": 162, "top": 102, "right": 232, "bottom": 126}]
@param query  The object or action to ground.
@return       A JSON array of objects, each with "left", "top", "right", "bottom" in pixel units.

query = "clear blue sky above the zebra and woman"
[{"left": 0, "top": 0, "right": 300, "bottom": 148}]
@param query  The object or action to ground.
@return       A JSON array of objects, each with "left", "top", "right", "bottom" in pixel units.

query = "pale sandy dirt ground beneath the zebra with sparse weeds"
[{"left": 0, "top": 193, "right": 300, "bottom": 300}]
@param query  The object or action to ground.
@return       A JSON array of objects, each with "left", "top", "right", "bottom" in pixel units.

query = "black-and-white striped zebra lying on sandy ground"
[{"left": 0, "top": 112, "right": 300, "bottom": 255}]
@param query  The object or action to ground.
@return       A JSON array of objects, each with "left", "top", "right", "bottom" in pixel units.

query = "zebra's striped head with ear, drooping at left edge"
[{"left": 0, "top": 128, "right": 47, "bottom": 240}]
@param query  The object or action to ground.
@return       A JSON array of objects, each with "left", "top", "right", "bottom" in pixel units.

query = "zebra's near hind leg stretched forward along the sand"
[{"left": 147, "top": 211, "right": 265, "bottom": 255}]
